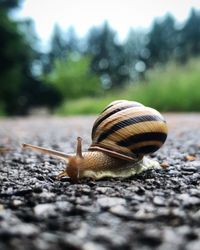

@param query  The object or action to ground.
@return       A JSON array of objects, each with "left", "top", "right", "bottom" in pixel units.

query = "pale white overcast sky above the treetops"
[{"left": 17, "top": 0, "right": 200, "bottom": 47}]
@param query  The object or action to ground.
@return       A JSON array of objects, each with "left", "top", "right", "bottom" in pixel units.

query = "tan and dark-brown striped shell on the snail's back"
[{"left": 89, "top": 100, "right": 167, "bottom": 161}]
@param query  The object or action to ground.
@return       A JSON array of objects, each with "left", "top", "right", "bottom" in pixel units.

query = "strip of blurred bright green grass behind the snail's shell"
[{"left": 56, "top": 59, "right": 200, "bottom": 115}]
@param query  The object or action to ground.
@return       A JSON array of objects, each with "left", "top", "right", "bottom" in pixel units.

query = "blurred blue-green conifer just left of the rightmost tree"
[{"left": 147, "top": 14, "right": 177, "bottom": 66}]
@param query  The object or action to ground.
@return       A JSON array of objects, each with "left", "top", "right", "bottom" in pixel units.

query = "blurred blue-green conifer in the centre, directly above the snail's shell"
[{"left": 87, "top": 22, "right": 128, "bottom": 88}]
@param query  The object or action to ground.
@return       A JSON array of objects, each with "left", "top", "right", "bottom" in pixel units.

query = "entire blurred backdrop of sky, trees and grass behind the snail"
[{"left": 0, "top": 0, "right": 200, "bottom": 116}]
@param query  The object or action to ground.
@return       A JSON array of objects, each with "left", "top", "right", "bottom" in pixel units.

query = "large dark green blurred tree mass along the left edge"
[{"left": 0, "top": 0, "right": 61, "bottom": 115}]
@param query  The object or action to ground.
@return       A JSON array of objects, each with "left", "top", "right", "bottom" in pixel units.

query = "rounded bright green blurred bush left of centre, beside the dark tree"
[{"left": 45, "top": 55, "right": 102, "bottom": 99}]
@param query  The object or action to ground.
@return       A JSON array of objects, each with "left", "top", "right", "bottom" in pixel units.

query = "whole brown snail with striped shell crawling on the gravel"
[{"left": 22, "top": 100, "right": 167, "bottom": 181}]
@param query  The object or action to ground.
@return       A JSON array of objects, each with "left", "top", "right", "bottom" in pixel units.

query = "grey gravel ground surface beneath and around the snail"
[{"left": 0, "top": 114, "right": 200, "bottom": 250}]
